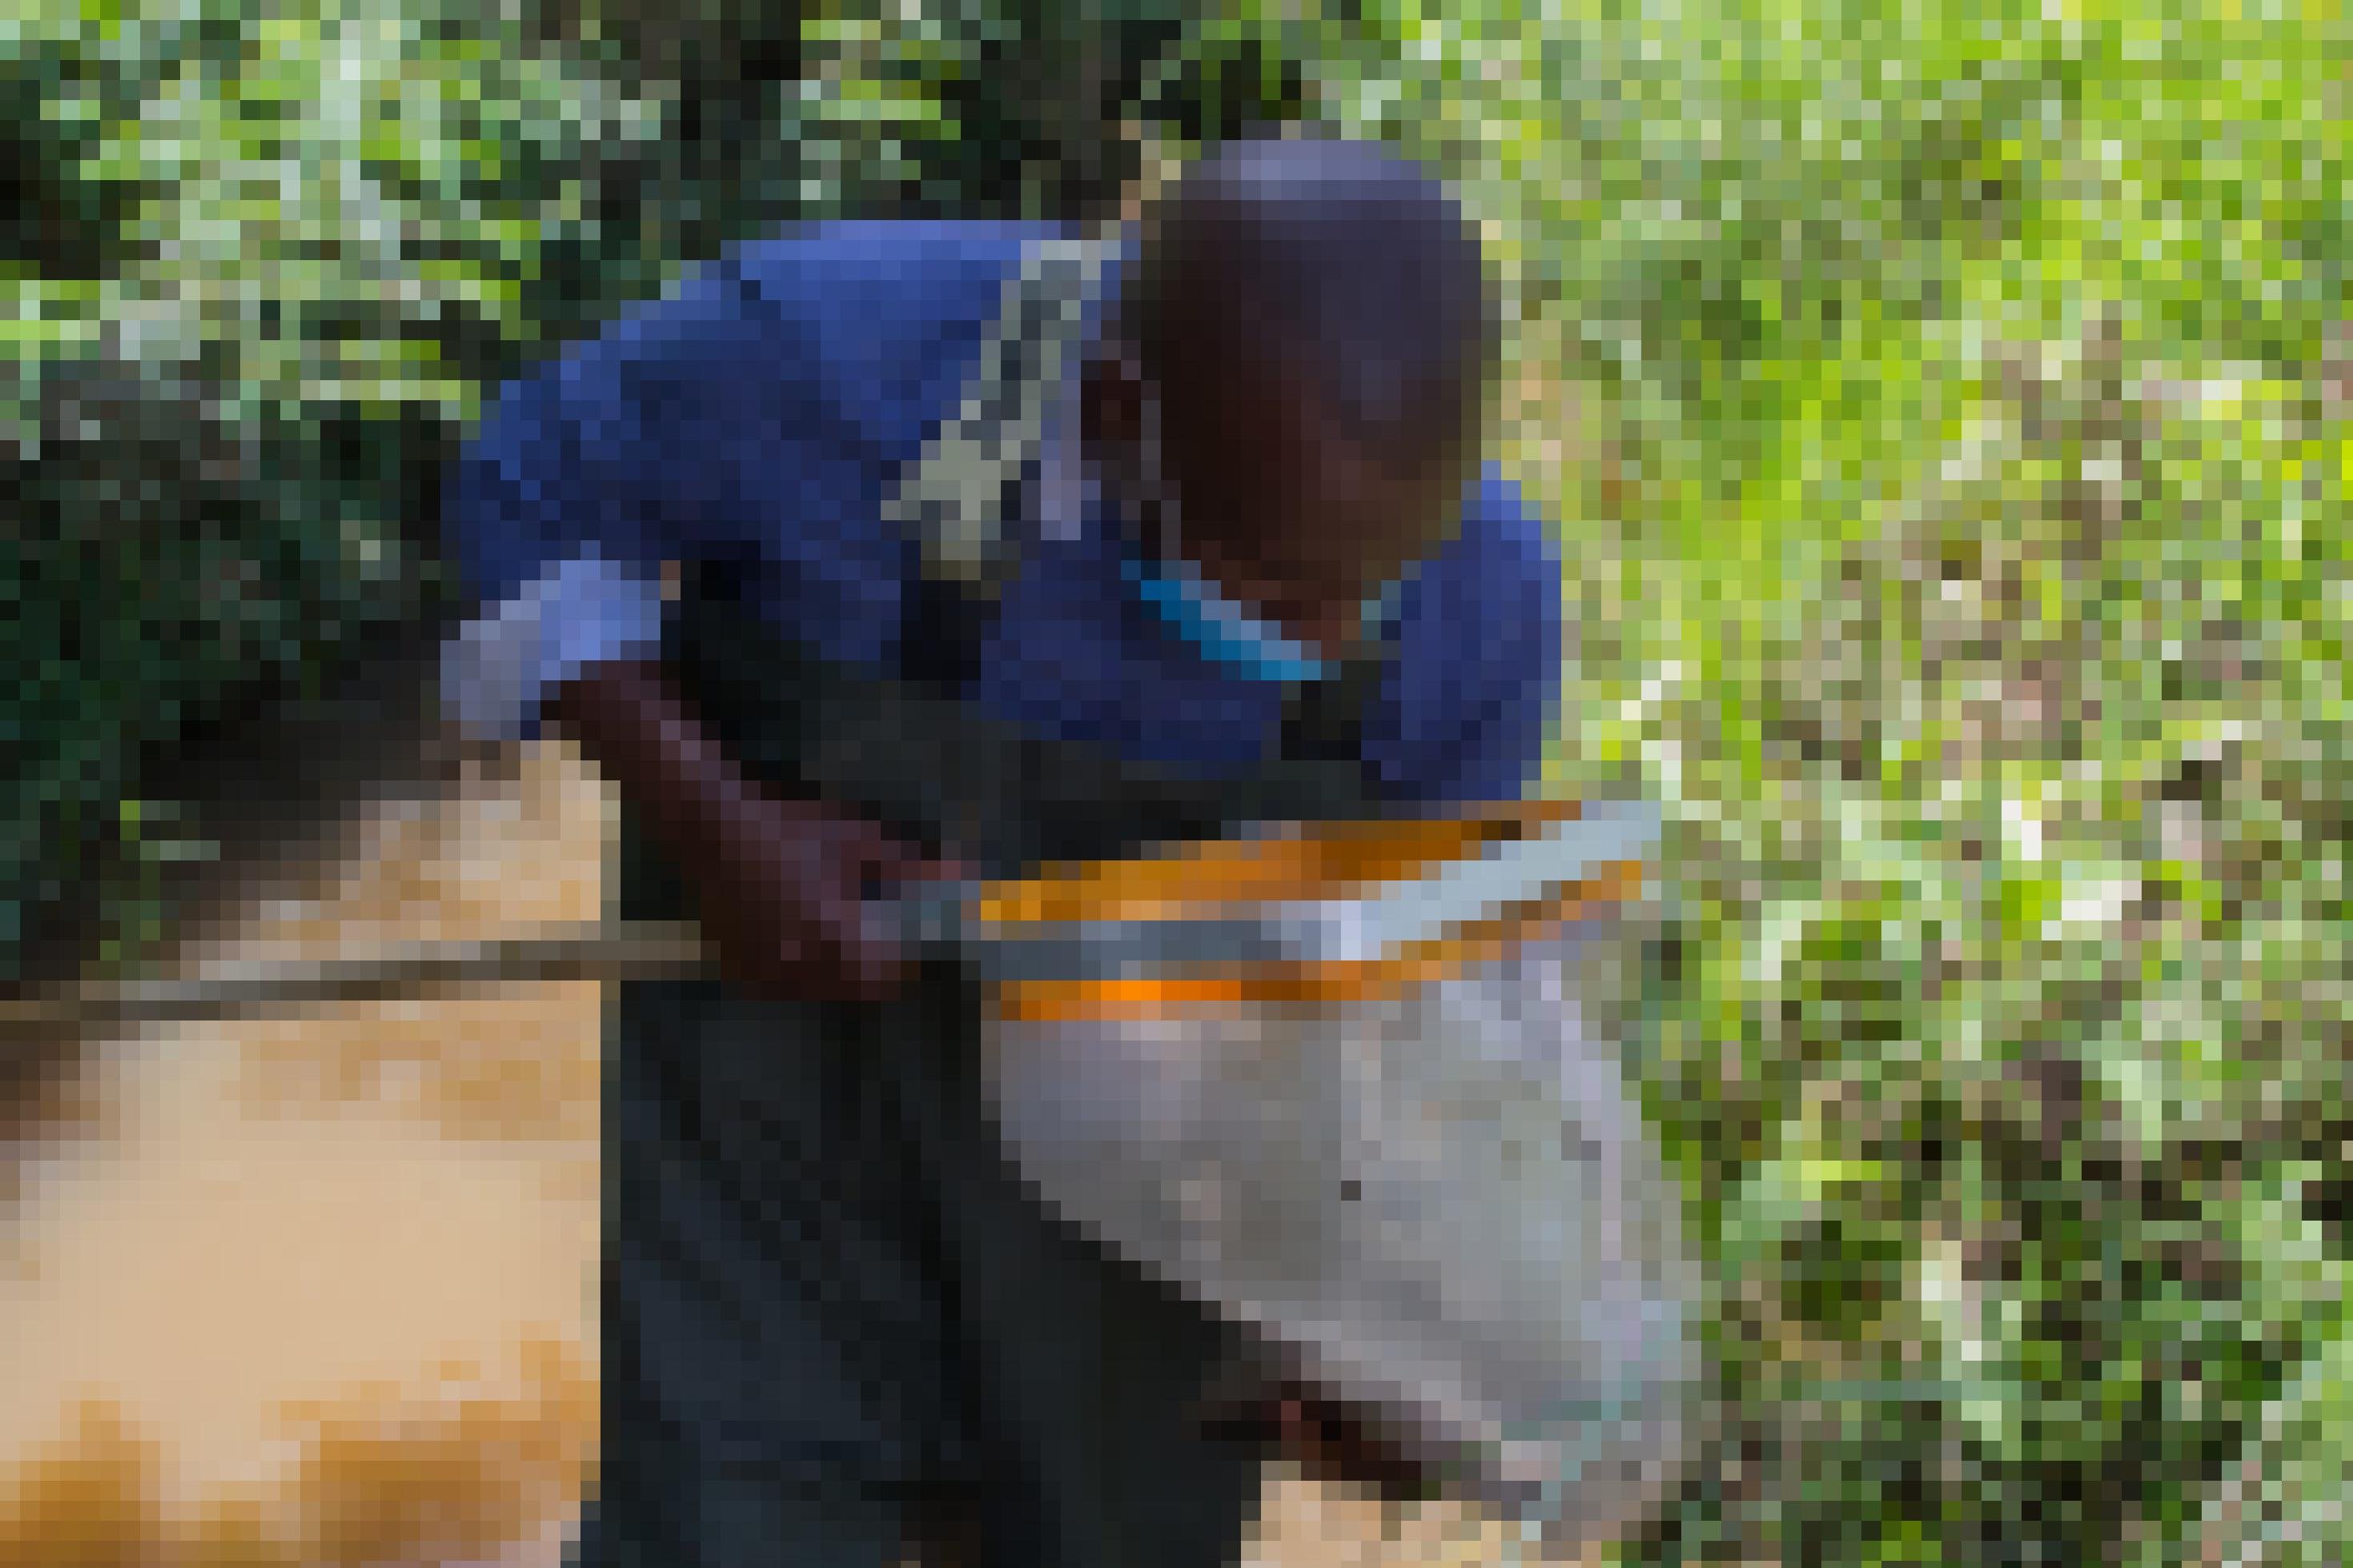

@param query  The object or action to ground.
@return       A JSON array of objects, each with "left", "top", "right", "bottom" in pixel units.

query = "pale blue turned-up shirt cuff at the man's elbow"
[{"left": 443, "top": 550, "right": 664, "bottom": 740}]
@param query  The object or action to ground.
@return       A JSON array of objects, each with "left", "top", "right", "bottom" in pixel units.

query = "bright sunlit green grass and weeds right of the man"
[{"left": 1129, "top": 0, "right": 2353, "bottom": 1563}]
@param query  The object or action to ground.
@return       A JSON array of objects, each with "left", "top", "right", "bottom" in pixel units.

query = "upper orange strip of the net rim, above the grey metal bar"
[{"left": 977, "top": 802, "right": 1584, "bottom": 926}]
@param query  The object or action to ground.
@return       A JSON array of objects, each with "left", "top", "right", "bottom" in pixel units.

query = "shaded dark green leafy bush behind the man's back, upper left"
[{"left": 0, "top": 0, "right": 1271, "bottom": 973}]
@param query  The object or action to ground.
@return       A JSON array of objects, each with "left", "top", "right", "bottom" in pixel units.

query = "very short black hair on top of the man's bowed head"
[{"left": 1122, "top": 136, "right": 1501, "bottom": 479}]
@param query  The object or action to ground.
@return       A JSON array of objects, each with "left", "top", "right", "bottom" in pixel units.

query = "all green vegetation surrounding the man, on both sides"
[{"left": 0, "top": 0, "right": 2353, "bottom": 1566}]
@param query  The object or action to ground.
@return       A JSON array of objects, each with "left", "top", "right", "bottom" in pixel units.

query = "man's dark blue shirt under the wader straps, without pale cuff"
[{"left": 444, "top": 221, "right": 1562, "bottom": 804}]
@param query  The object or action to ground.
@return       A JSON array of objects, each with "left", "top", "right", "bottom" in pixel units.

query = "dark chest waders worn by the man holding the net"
[{"left": 581, "top": 580, "right": 1369, "bottom": 1568}]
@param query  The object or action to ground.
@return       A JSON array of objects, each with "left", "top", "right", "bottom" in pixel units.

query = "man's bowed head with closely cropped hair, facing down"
[{"left": 1087, "top": 128, "right": 1499, "bottom": 652}]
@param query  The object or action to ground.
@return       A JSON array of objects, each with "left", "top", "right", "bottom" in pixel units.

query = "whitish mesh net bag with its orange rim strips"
[{"left": 964, "top": 806, "right": 1699, "bottom": 1545}]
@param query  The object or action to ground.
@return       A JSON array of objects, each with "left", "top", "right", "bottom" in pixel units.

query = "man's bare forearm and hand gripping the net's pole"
[{"left": 546, "top": 663, "right": 960, "bottom": 1001}]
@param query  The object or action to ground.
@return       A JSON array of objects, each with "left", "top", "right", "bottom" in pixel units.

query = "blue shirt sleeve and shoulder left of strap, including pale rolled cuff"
[{"left": 443, "top": 221, "right": 1023, "bottom": 752}]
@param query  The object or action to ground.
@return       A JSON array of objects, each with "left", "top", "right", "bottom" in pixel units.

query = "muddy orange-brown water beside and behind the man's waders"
[{"left": 0, "top": 745, "right": 1590, "bottom": 1568}]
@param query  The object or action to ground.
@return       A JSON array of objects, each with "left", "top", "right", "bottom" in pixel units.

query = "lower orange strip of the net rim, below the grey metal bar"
[{"left": 990, "top": 860, "right": 1644, "bottom": 1023}]
